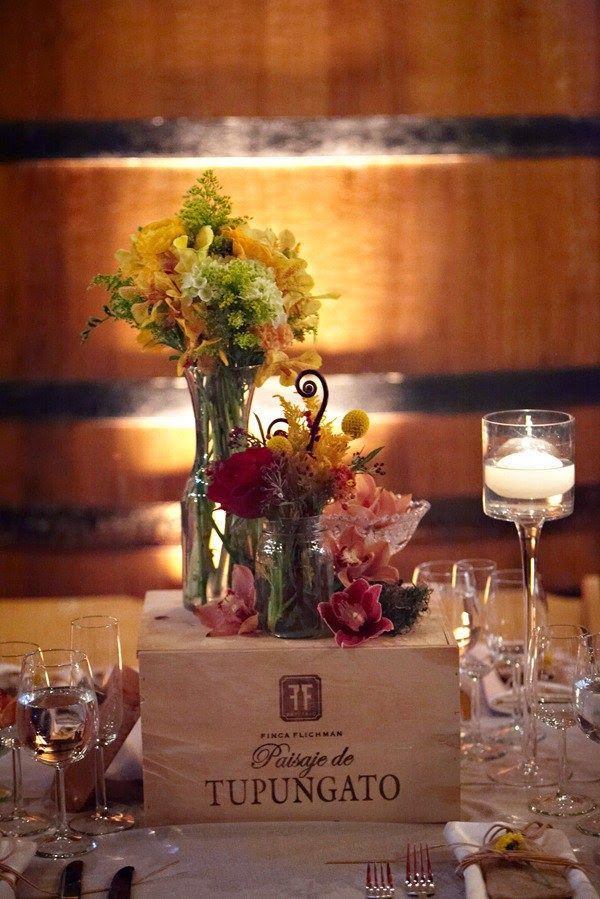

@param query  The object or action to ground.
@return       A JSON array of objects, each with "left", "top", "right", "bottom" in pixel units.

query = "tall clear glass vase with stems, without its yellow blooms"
[{"left": 181, "top": 365, "right": 258, "bottom": 609}]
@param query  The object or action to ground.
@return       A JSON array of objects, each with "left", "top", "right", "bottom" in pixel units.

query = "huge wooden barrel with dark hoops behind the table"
[{"left": 0, "top": 0, "right": 600, "bottom": 596}]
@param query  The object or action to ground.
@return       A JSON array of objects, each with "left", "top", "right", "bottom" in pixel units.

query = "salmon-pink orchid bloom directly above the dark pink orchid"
[{"left": 326, "top": 527, "right": 400, "bottom": 587}]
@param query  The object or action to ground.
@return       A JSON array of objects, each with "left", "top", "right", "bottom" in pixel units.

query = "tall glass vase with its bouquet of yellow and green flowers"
[{"left": 82, "top": 171, "right": 332, "bottom": 607}]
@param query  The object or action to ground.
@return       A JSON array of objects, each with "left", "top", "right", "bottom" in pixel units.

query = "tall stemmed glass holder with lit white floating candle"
[{"left": 482, "top": 409, "right": 575, "bottom": 786}]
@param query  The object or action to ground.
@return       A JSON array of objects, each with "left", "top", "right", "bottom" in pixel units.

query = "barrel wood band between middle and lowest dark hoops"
[{"left": 0, "top": 406, "right": 600, "bottom": 510}]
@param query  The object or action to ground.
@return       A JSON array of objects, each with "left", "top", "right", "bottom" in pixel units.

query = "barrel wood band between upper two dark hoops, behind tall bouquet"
[{"left": 0, "top": 157, "right": 600, "bottom": 379}]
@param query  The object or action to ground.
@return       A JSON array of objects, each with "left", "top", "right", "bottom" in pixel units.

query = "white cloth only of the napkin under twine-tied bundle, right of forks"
[{"left": 444, "top": 821, "right": 599, "bottom": 899}]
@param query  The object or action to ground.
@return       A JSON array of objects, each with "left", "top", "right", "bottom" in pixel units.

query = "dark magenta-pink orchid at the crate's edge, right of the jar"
[{"left": 317, "top": 578, "right": 394, "bottom": 646}]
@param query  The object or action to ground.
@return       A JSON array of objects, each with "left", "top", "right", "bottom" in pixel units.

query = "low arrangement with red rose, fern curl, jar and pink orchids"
[{"left": 202, "top": 371, "right": 429, "bottom": 646}]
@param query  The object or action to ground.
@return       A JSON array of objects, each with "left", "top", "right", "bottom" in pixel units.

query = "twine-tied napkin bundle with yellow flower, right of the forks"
[{"left": 444, "top": 821, "right": 599, "bottom": 899}]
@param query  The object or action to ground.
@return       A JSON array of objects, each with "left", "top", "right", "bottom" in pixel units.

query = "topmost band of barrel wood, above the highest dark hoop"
[{"left": 0, "top": 0, "right": 600, "bottom": 119}]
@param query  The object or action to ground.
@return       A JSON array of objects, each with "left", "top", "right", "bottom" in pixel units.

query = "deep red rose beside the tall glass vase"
[{"left": 207, "top": 446, "right": 274, "bottom": 518}]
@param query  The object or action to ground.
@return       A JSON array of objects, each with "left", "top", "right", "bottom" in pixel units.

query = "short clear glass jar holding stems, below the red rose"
[{"left": 256, "top": 516, "right": 333, "bottom": 640}]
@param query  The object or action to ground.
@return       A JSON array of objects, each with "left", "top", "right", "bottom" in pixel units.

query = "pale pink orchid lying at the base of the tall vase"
[{"left": 194, "top": 565, "right": 258, "bottom": 637}]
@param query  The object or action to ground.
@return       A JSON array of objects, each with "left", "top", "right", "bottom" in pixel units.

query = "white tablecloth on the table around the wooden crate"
[{"left": 0, "top": 728, "right": 600, "bottom": 899}]
